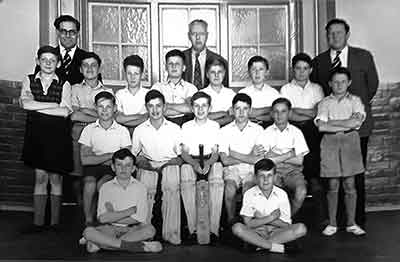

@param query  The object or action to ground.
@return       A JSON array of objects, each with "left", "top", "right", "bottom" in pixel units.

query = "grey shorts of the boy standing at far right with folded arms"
[{"left": 321, "top": 131, "right": 364, "bottom": 177}]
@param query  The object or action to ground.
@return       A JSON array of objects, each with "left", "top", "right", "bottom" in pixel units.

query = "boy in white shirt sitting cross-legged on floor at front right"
[{"left": 232, "top": 159, "right": 307, "bottom": 253}]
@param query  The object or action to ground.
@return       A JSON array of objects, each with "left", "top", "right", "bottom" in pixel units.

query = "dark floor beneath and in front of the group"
[{"left": 0, "top": 207, "right": 400, "bottom": 262}]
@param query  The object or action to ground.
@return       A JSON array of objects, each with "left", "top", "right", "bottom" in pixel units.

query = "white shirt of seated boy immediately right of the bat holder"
[{"left": 219, "top": 121, "right": 264, "bottom": 155}]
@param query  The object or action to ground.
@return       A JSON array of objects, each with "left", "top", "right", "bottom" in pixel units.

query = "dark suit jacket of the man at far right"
[{"left": 310, "top": 46, "right": 379, "bottom": 137}]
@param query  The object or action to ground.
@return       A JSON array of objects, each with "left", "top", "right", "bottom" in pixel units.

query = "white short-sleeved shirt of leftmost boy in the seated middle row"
[{"left": 78, "top": 120, "right": 132, "bottom": 155}]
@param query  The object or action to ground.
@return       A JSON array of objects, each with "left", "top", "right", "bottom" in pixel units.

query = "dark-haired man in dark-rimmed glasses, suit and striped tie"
[{"left": 35, "top": 15, "right": 85, "bottom": 85}]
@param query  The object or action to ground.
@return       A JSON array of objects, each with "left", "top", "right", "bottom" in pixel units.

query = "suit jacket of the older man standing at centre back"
[{"left": 183, "top": 48, "right": 229, "bottom": 88}]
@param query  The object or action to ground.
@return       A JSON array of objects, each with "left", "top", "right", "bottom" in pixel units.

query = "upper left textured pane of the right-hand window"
[{"left": 229, "top": 8, "right": 257, "bottom": 45}]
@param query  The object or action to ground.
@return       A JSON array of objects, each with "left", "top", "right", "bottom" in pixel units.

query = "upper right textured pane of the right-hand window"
[{"left": 260, "top": 8, "right": 286, "bottom": 44}]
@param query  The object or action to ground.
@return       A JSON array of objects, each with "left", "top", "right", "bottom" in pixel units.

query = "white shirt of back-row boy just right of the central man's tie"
[{"left": 201, "top": 85, "right": 236, "bottom": 112}]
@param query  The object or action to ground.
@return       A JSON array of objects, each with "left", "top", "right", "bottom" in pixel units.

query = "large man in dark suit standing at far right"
[{"left": 311, "top": 18, "right": 379, "bottom": 225}]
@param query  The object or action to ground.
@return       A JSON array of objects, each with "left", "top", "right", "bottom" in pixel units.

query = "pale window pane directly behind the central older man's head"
[{"left": 190, "top": 9, "right": 219, "bottom": 46}]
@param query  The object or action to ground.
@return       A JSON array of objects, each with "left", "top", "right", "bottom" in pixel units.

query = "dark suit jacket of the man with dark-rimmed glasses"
[{"left": 35, "top": 46, "right": 86, "bottom": 85}]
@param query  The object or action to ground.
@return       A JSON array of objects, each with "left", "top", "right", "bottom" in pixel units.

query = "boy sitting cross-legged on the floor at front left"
[{"left": 79, "top": 148, "right": 162, "bottom": 253}]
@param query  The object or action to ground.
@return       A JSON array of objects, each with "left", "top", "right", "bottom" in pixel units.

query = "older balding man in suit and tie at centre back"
[{"left": 183, "top": 19, "right": 229, "bottom": 90}]
